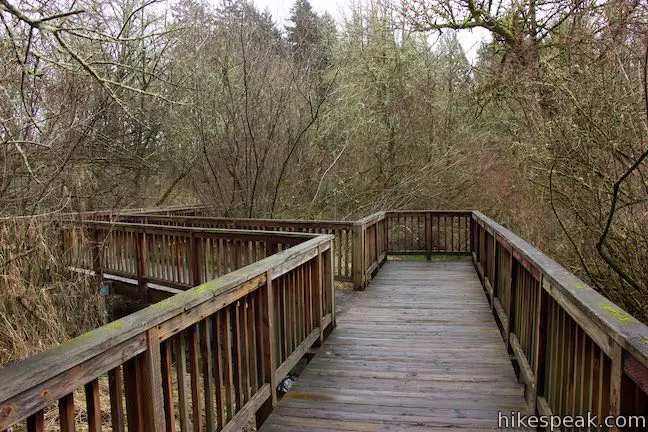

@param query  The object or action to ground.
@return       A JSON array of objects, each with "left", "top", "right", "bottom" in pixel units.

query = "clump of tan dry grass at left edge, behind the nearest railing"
[{"left": 0, "top": 219, "right": 106, "bottom": 366}]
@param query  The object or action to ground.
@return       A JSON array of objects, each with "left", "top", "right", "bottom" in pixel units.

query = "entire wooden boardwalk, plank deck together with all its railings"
[{"left": 0, "top": 206, "right": 648, "bottom": 432}]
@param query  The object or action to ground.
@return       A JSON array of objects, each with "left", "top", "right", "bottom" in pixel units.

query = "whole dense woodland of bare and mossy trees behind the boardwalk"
[{"left": 0, "top": 0, "right": 648, "bottom": 328}]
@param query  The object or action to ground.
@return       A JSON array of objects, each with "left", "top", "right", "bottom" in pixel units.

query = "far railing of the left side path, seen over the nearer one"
[{"left": 107, "top": 215, "right": 358, "bottom": 285}]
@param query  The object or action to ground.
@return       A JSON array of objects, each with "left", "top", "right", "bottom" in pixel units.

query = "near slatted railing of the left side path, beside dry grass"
[{"left": 62, "top": 221, "right": 315, "bottom": 298}]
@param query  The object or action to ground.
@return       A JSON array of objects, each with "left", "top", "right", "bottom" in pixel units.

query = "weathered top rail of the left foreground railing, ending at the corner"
[{"left": 0, "top": 234, "right": 334, "bottom": 403}]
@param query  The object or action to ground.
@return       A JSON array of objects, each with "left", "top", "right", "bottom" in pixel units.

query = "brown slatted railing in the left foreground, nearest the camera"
[{"left": 0, "top": 235, "right": 335, "bottom": 432}]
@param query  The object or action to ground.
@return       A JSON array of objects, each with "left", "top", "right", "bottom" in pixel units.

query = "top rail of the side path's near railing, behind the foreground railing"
[{"left": 66, "top": 216, "right": 323, "bottom": 239}]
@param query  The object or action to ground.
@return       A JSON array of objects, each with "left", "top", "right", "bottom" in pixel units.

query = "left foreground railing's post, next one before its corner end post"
[{"left": 256, "top": 270, "right": 278, "bottom": 427}]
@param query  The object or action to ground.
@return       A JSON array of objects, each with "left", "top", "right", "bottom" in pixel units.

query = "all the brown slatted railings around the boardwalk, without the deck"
[{"left": 0, "top": 211, "right": 648, "bottom": 431}]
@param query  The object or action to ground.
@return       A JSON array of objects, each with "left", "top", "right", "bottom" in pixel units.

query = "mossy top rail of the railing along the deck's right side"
[{"left": 473, "top": 211, "right": 648, "bottom": 367}]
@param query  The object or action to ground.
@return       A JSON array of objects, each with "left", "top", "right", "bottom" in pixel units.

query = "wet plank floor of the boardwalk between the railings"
[{"left": 261, "top": 261, "right": 528, "bottom": 432}]
